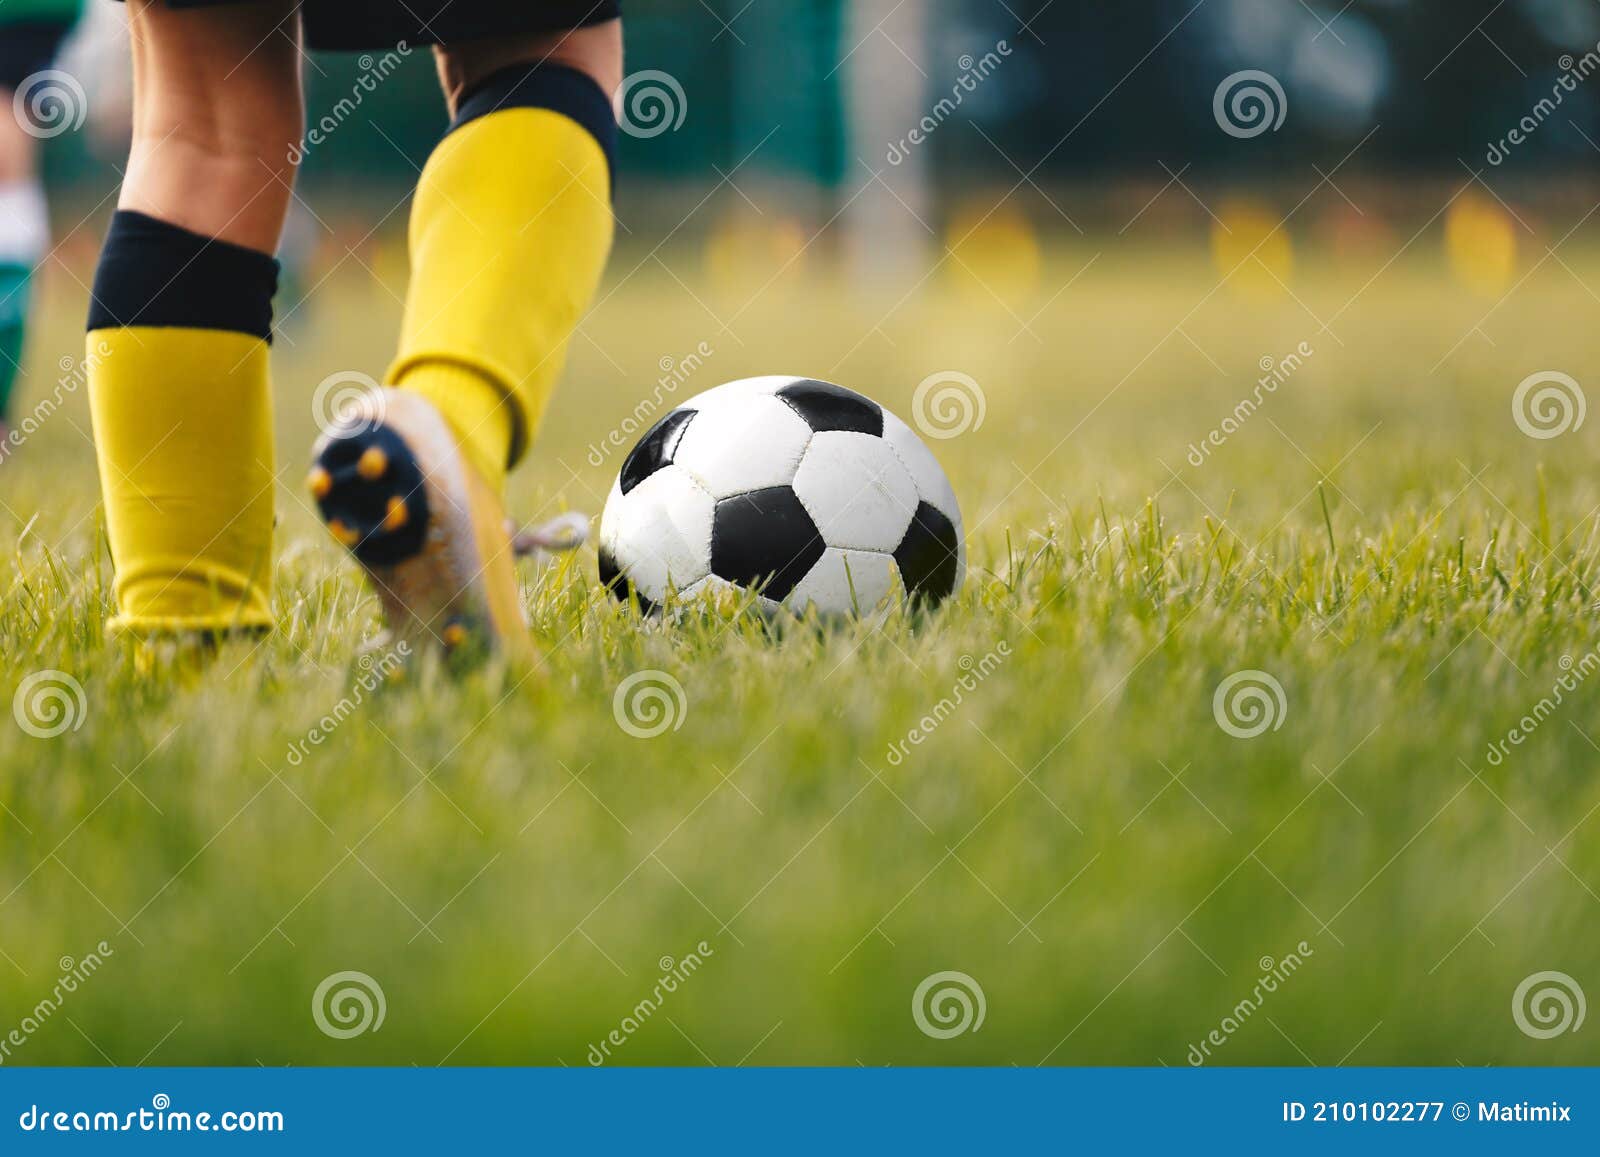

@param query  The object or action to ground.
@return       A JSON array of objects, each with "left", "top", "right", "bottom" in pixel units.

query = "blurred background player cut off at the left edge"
[{"left": 0, "top": 0, "right": 80, "bottom": 448}]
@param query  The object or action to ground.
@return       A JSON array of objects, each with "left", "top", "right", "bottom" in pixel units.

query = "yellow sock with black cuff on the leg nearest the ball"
[{"left": 389, "top": 66, "right": 614, "bottom": 493}]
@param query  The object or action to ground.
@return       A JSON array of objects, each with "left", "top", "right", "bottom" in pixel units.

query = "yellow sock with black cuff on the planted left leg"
[{"left": 86, "top": 213, "right": 277, "bottom": 634}]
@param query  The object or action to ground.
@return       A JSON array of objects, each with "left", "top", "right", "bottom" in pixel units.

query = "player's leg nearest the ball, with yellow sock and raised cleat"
[{"left": 312, "top": 19, "right": 622, "bottom": 647}]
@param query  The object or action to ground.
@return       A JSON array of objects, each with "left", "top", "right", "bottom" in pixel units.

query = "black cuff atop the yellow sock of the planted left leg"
[{"left": 88, "top": 210, "right": 278, "bottom": 341}]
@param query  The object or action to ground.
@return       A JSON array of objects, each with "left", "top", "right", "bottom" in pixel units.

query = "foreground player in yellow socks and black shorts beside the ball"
[{"left": 88, "top": 0, "right": 622, "bottom": 650}]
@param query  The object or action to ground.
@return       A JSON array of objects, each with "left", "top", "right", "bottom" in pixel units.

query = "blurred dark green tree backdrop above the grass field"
[{"left": 40, "top": 0, "right": 1600, "bottom": 189}]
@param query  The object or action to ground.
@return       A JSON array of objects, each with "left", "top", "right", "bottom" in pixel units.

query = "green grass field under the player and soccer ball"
[{"left": 0, "top": 212, "right": 1600, "bottom": 1064}]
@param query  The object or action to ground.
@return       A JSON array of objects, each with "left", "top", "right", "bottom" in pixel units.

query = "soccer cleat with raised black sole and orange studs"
[{"left": 307, "top": 387, "right": 531, "bottom": 655}]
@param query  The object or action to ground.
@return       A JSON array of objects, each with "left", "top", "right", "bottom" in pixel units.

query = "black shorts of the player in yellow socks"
[{"left": 134, "top": 0, "right": 621, "bottom": 51}]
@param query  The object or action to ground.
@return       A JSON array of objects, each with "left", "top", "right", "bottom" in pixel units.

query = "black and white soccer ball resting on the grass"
[{"left": 600, "top": 376, "right": 966, "bottom": 615}]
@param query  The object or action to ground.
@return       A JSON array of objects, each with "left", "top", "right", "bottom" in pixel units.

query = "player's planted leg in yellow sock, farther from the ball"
[{"left": 88, "top": 0, "right": 301, "bottom": 632}]
